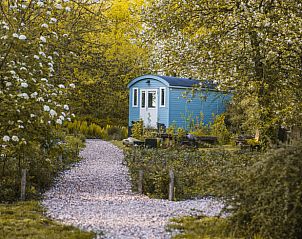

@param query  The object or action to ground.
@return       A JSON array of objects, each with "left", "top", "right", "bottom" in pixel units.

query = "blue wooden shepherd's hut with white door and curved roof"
[{"left": 128, "top": 75, "right": 231, "bottom": 129}]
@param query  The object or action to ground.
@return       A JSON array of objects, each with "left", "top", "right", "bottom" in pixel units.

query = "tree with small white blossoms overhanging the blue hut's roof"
[{"left": 146, "top": 0, "right": 302, "bottom": 138}]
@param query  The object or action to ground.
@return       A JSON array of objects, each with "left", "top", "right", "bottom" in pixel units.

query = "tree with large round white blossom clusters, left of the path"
[{"left": 0, "top": 0, "right": 85, "bottom": 201}]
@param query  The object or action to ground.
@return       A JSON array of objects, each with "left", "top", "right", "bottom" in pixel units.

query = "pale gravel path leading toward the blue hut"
[{"left": 42, "top": 140, "right": 222, "bottom": 239}]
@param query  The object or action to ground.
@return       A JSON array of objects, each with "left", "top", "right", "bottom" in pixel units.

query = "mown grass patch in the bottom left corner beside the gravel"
[{"left": 0, "top": 201, "right": 95, "bottom": 239}]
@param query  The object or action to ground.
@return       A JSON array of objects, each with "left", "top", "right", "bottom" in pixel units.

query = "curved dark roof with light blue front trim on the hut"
[{"left": 128, "top": 75, "right": 200, "bottom": 87}]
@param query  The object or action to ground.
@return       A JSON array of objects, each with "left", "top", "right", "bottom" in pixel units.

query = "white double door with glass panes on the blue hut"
[{"left": 140, "top": 89, "right": 157, "bottom": 128}]
